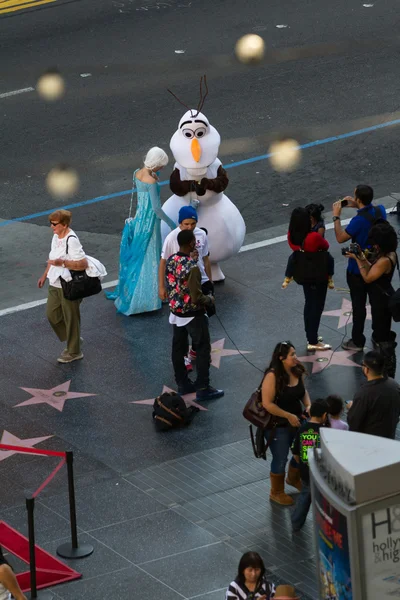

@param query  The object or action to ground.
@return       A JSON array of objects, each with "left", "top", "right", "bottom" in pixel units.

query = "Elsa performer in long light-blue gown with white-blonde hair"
[{"left": 106, "top": 146, "right": 176, "bottom": 315}]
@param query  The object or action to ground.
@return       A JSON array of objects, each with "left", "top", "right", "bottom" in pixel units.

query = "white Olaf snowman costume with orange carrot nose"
[{"left": 161, "top": 109, "right": 246, "bottom": 281}]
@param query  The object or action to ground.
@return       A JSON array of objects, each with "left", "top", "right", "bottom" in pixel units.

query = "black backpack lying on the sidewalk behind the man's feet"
[{"left": 153, "top": 392, "right": 199, "bottom": 431}]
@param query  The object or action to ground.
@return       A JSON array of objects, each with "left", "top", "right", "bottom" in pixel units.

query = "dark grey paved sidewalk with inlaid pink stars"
[{"left": 0, "top": 221, "right": 400, "bottom": 600}]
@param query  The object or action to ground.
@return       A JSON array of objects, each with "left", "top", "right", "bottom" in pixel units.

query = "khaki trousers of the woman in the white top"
[{"left": 46, "top": 285, "right": 82, "bottom": 356}]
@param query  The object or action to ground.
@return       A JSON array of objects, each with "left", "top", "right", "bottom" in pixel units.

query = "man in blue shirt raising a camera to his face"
[{"left": 332, "top": 185, "right": 386, "bottom": 350}]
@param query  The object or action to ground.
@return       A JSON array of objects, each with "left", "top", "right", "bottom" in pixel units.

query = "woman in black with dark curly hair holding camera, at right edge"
[{"left": 346, "top": 221, "right": 398, "bottom": 377}]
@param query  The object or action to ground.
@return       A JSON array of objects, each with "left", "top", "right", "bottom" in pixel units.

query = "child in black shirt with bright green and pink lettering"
[{"left": 291, "top": 399, "right": 328, "bottom": 531}]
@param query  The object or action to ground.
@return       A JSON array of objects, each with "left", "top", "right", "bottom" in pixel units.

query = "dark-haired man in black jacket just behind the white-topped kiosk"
[{"left": 347, "top": 350, "right": 400, "bottom": 439}]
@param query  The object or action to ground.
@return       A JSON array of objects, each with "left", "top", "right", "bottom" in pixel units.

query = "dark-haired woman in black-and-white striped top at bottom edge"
[{"left": 225, "top": 552, "right": 275, "bottom": 600}]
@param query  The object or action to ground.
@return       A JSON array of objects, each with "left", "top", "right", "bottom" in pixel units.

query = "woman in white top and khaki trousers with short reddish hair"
[{"left": 38, "top": 210, "right": 88, "bottom": 363}]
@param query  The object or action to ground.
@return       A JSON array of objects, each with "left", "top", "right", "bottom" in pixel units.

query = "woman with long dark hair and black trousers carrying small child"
[{"left": 288, "top": 207, "right": 332, "bottom": 352}]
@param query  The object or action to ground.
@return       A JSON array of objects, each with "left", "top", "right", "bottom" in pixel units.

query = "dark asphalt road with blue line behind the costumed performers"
[{"left": 0, "top": 0, "right": 400, "bottom": 310}]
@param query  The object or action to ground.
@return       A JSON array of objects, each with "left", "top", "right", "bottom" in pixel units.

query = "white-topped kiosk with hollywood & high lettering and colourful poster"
[{"left": 309, "top": 428, "right": 400, "bottom": 600}]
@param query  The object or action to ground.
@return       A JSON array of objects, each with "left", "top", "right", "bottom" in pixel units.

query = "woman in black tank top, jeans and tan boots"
[{"left": 261, "top": 341, "right": 311, "bottom": 506}]
